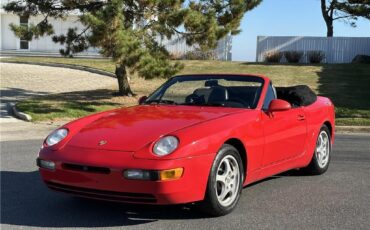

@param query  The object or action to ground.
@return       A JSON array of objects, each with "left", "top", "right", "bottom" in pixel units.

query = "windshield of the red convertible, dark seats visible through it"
[{"left": 144, "top": 75, "right": 263, "bottom": 109}]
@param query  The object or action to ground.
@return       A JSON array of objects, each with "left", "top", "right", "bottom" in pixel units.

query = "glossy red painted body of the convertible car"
[{"left": 39, "top": 75, "right": 335, "bottom": 204}]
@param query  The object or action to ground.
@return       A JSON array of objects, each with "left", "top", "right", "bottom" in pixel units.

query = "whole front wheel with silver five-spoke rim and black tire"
[{"left": 200, "top": 144, "right": 244, "bottom": 216}]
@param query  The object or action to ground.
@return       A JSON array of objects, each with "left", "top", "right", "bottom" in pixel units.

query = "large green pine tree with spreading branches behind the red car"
[{"left": 4, "top": 0, "right": 262, "bottom": 95}]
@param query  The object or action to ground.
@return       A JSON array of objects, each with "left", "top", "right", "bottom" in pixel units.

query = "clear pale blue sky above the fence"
[{"left": 232, "top": 0, "right": 370, "bottom": 61}]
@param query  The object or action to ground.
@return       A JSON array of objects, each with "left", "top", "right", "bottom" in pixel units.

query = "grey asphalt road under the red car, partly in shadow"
[{"left": 1, "top": 135, "right": 370, "bottom": 230}]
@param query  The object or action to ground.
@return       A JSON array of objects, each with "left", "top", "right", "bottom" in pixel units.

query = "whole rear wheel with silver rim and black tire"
[{"left": 304, "top": 125, "right": 331, "bottom": 175}]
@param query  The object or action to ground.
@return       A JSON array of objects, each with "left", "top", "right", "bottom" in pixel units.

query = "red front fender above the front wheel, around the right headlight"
[{"left": 134, "top": 110, "right": 264, "bottom": 175}]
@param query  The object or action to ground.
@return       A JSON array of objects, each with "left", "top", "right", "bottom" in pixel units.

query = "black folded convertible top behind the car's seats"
[{"left": 276, "top": 85, "right": 317, "bottom": 107}]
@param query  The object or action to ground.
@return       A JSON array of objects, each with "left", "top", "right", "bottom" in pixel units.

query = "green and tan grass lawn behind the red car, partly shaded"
[{"left": 2, "top": 57, "right": 370, "bottom": 125}]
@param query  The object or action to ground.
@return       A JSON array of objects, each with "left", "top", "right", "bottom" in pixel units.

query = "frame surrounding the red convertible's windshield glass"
[{"left": 143, "top": 74, "right": 266, "bottom": 109}]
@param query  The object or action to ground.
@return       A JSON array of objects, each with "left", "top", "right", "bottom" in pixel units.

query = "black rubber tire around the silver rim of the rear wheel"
[{"left": 303, "top": 125, "right": 331, "bottom": 175}]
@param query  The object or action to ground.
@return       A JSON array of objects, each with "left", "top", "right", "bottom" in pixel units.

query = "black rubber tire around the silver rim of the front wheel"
[{"left": 198, "top": 144, "right": 244, "bottom": 216}]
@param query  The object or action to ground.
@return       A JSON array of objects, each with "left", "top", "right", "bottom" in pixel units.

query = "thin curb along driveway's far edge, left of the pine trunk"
[{"left": 1, "top": 60, "right": 116, "bottom": 78}]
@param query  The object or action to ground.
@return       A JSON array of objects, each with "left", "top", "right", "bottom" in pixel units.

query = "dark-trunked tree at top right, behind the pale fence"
[{"left": 321, "top": 0, "right": 370, "bottom": 37}]
